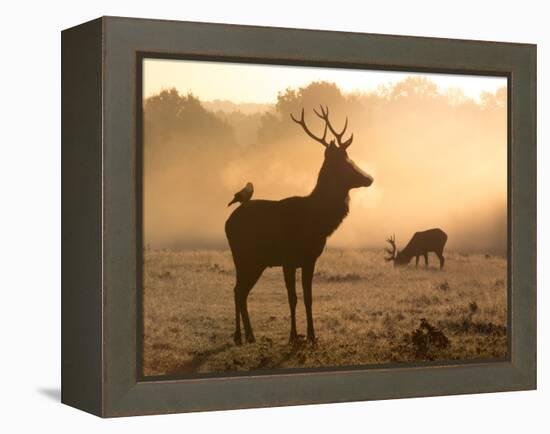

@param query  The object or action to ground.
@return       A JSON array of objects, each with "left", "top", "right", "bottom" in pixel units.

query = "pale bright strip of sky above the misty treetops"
[{"left": 143, "top": 59, "right": 506, "bottom": 103}]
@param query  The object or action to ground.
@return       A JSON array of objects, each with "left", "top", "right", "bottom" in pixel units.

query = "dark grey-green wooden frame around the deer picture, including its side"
[{"left": 62, "top": 17, "right": 536, "bottom": 417}]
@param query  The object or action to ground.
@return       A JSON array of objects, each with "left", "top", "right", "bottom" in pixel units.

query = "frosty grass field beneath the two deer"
[{"left": 143, "top": 249, "right": 507, "bottom": 376}]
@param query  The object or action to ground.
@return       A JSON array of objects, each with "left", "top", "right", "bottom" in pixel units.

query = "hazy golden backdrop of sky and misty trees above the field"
[{"left": 143, "top": 59, "right": 507, "bottom": 252}]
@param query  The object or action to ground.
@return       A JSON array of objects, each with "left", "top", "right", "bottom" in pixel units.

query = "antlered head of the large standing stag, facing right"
[{"left": 290, "top": 106, "right": 373, "bottom": 193}]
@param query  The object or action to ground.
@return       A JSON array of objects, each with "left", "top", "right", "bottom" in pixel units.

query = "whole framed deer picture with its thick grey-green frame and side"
[{"left": 62, "top": 17, "right": 536, "bottom": 417}]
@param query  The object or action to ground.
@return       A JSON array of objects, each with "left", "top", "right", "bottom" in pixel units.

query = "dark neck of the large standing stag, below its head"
[{"left": 309, "top": 169, "right": 349, "bottom": 237}]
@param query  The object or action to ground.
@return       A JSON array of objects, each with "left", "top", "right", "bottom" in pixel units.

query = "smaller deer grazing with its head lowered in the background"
[{"left": 384, "top": 229, "right": 447, "bottom": 268}]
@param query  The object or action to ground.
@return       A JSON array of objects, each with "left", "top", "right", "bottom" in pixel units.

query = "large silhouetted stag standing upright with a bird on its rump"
[{"left": 225, "top": 107, "right": 373, "bottom": 345}]
